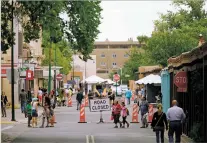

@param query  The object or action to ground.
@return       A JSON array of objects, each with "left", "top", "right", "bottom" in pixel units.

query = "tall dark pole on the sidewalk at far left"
[{"left": 11, "top": 0, "right": 16, "bottom": 121}]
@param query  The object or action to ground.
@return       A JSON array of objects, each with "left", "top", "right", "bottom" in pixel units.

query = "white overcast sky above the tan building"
[{"left": 63, "top": 0, "right": 207, "bottom": 41}]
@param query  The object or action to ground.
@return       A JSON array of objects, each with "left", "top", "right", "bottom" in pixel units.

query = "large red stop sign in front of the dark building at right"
[{"left": 174, "top": 71, "right": 188, "bottom": 92}]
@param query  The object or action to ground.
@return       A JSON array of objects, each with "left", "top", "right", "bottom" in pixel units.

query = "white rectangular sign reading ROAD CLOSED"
[{"left": 90, "top": 98, "right": 111, "bottom": 112}]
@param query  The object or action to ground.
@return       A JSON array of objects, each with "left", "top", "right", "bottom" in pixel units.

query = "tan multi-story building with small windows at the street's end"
[{"left": 92, "top": 38, "right": 141, "bottom": 79}]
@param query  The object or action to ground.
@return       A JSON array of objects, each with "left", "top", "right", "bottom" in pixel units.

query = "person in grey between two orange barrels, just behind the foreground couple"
[{"left": 139, "top": 97, "right": 149, "bottom": 128}]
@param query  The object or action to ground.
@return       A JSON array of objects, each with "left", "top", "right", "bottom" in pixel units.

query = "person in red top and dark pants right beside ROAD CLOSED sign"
[{"left": 114, "top": 101, "right": 122, "bottom": 128}]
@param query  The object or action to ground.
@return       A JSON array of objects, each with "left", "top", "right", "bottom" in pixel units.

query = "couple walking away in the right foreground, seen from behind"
[{"left": 151, "top": 100, "right": 186, "bottom": 143}]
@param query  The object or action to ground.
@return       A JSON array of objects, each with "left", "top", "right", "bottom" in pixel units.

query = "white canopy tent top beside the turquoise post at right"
[{"left": 135, "top": 74, "right": 161, "bottom": 84}]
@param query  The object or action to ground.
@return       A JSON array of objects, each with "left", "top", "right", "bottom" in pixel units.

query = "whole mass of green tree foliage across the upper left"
[{"left": 1, "top": 0, "right": 102, "bottom": 61}]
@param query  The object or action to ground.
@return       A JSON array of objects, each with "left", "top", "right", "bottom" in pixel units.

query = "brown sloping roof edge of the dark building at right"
[{"left": 167, "top": 42, "right": 207, "bottom": 67}]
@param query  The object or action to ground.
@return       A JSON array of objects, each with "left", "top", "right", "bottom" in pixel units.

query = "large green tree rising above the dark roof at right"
[{"left": 146, "top": 0, "right": 207, "bottom": 66}]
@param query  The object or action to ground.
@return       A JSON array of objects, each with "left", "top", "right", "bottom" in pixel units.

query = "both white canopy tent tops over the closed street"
[{"left": 81, "top": 74, "right": 161, "bottom": 85}]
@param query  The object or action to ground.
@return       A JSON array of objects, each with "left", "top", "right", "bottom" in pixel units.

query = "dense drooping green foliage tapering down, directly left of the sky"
[{"left": 65, "top": 1, "right": 102, "bottom": 61}]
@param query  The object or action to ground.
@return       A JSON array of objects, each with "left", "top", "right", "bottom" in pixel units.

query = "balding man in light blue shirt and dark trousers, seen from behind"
[{"left": 167, "top": 100, "right": 186, "bottom": 143}]
